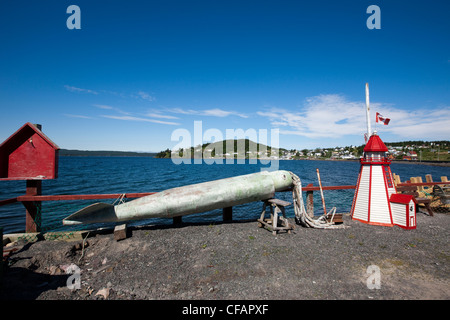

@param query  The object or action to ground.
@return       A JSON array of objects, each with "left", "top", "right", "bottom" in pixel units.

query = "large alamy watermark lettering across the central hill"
[{"left": 171, "top": 121, "right": 280, "bottom": 170}]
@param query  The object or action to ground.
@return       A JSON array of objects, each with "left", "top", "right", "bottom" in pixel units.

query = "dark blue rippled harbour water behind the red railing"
[{"left": 0, "top": 157, "right": 450, "bottom": 233}]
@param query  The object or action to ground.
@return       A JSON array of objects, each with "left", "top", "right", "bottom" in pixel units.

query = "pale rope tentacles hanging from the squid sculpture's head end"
[{"left": 290, "top": 172, "right": 346, "bottom": 229}]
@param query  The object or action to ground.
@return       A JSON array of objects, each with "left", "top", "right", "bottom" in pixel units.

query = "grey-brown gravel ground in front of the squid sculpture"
[{"left": 0, "top": 213, "right": 450, "bottom": 300}]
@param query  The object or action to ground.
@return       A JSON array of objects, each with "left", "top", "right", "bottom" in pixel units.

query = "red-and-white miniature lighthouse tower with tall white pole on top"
[{"left": 351, "top": 84, "right": 396, "bottom": 226}]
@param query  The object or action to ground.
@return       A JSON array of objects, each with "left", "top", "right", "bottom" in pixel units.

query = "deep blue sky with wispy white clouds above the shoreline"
[{"left": 0, "top": 0, "right": 450, "bottom": 151}]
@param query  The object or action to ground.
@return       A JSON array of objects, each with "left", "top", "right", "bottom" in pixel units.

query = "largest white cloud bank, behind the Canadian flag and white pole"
[{"left": 257, "top": 94, "right": 450, "bottom": 140}]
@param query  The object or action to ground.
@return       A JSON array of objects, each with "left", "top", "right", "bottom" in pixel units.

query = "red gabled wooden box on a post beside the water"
[{"left": 0, "top": 122, "right": 59, "bottom": 180}]
